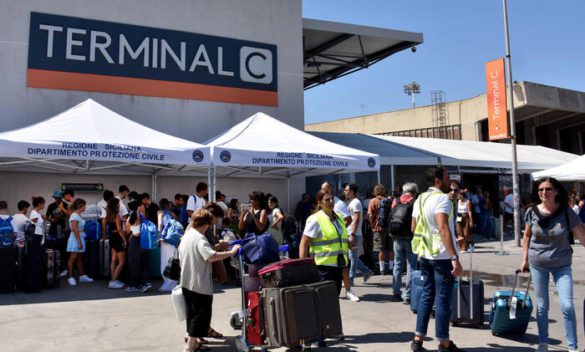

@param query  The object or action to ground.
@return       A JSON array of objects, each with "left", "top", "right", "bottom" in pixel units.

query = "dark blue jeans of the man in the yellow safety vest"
[{"left": 415, "top": 258, "right": 455, "bottom": 341}]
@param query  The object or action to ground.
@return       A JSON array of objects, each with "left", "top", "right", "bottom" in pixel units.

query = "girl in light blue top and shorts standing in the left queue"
[{"left": 67, "top": 198, "right": 93, "bottom": 286}]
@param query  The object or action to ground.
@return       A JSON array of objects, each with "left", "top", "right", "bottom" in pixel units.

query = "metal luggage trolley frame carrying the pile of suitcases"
[{"left": 230, "top": 240, "right": 311, "bottom": 352}]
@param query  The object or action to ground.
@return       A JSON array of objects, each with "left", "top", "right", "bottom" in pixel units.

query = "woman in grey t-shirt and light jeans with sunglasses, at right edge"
[{"left": 520, "top": 178, "right": 585, "bottom": 352}]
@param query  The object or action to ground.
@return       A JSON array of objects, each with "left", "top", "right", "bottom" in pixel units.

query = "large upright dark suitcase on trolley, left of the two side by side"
[{"left": 262, "top": 285, "right": 322, "bottom": 348}]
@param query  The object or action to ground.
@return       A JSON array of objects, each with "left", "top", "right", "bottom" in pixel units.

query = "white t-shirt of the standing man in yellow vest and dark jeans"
[{"left": 412, "top": 187, "right": 459, "bottom": 260}]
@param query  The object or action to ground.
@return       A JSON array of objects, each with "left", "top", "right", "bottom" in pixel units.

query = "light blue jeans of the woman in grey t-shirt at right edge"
[{"left": 530, "top": 265, "right": 577, "bottom": 349}]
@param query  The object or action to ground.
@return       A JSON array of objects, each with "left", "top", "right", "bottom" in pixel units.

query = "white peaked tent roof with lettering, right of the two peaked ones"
[{"left": 206, "top": 112, "right": 380, "bottom": 176}]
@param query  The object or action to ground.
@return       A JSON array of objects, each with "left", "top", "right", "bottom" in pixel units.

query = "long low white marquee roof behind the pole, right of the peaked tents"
[{"left": 314, "top": 133, "right": 577, "bottom": 172}]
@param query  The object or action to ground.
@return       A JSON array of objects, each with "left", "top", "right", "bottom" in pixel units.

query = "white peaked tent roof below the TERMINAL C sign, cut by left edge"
[{"left": 0, "top": 99, "right": 210, "bottom": 173}]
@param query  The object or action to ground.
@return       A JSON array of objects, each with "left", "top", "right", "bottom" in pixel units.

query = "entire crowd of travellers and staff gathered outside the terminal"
[{"left": 0, "top": 168, "right": 585, "bottom": 352}]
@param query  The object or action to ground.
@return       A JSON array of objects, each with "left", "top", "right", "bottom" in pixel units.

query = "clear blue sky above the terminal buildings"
[{"left": 303, "top": 0, "right": 585, "bottom": 123}]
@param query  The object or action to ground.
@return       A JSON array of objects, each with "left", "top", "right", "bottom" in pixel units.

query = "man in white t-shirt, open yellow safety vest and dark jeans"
[{"left": 410, "top": 167, "right": 463, "bottom": 352}]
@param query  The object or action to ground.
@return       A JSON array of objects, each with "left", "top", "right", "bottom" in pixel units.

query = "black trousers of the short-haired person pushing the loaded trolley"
[{"left": 182, "top": 287, "right": 213, "bottom": 338}]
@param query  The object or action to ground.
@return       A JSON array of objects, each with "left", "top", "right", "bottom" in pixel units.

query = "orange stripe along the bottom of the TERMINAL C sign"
[{"left": 27, "top": 69, "right": 278, "bottom": 106}]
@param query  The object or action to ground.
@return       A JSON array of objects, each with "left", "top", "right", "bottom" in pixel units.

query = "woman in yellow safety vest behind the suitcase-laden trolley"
[{"left": 299, "top": 189, "right": 349, "bottom": 294}]
